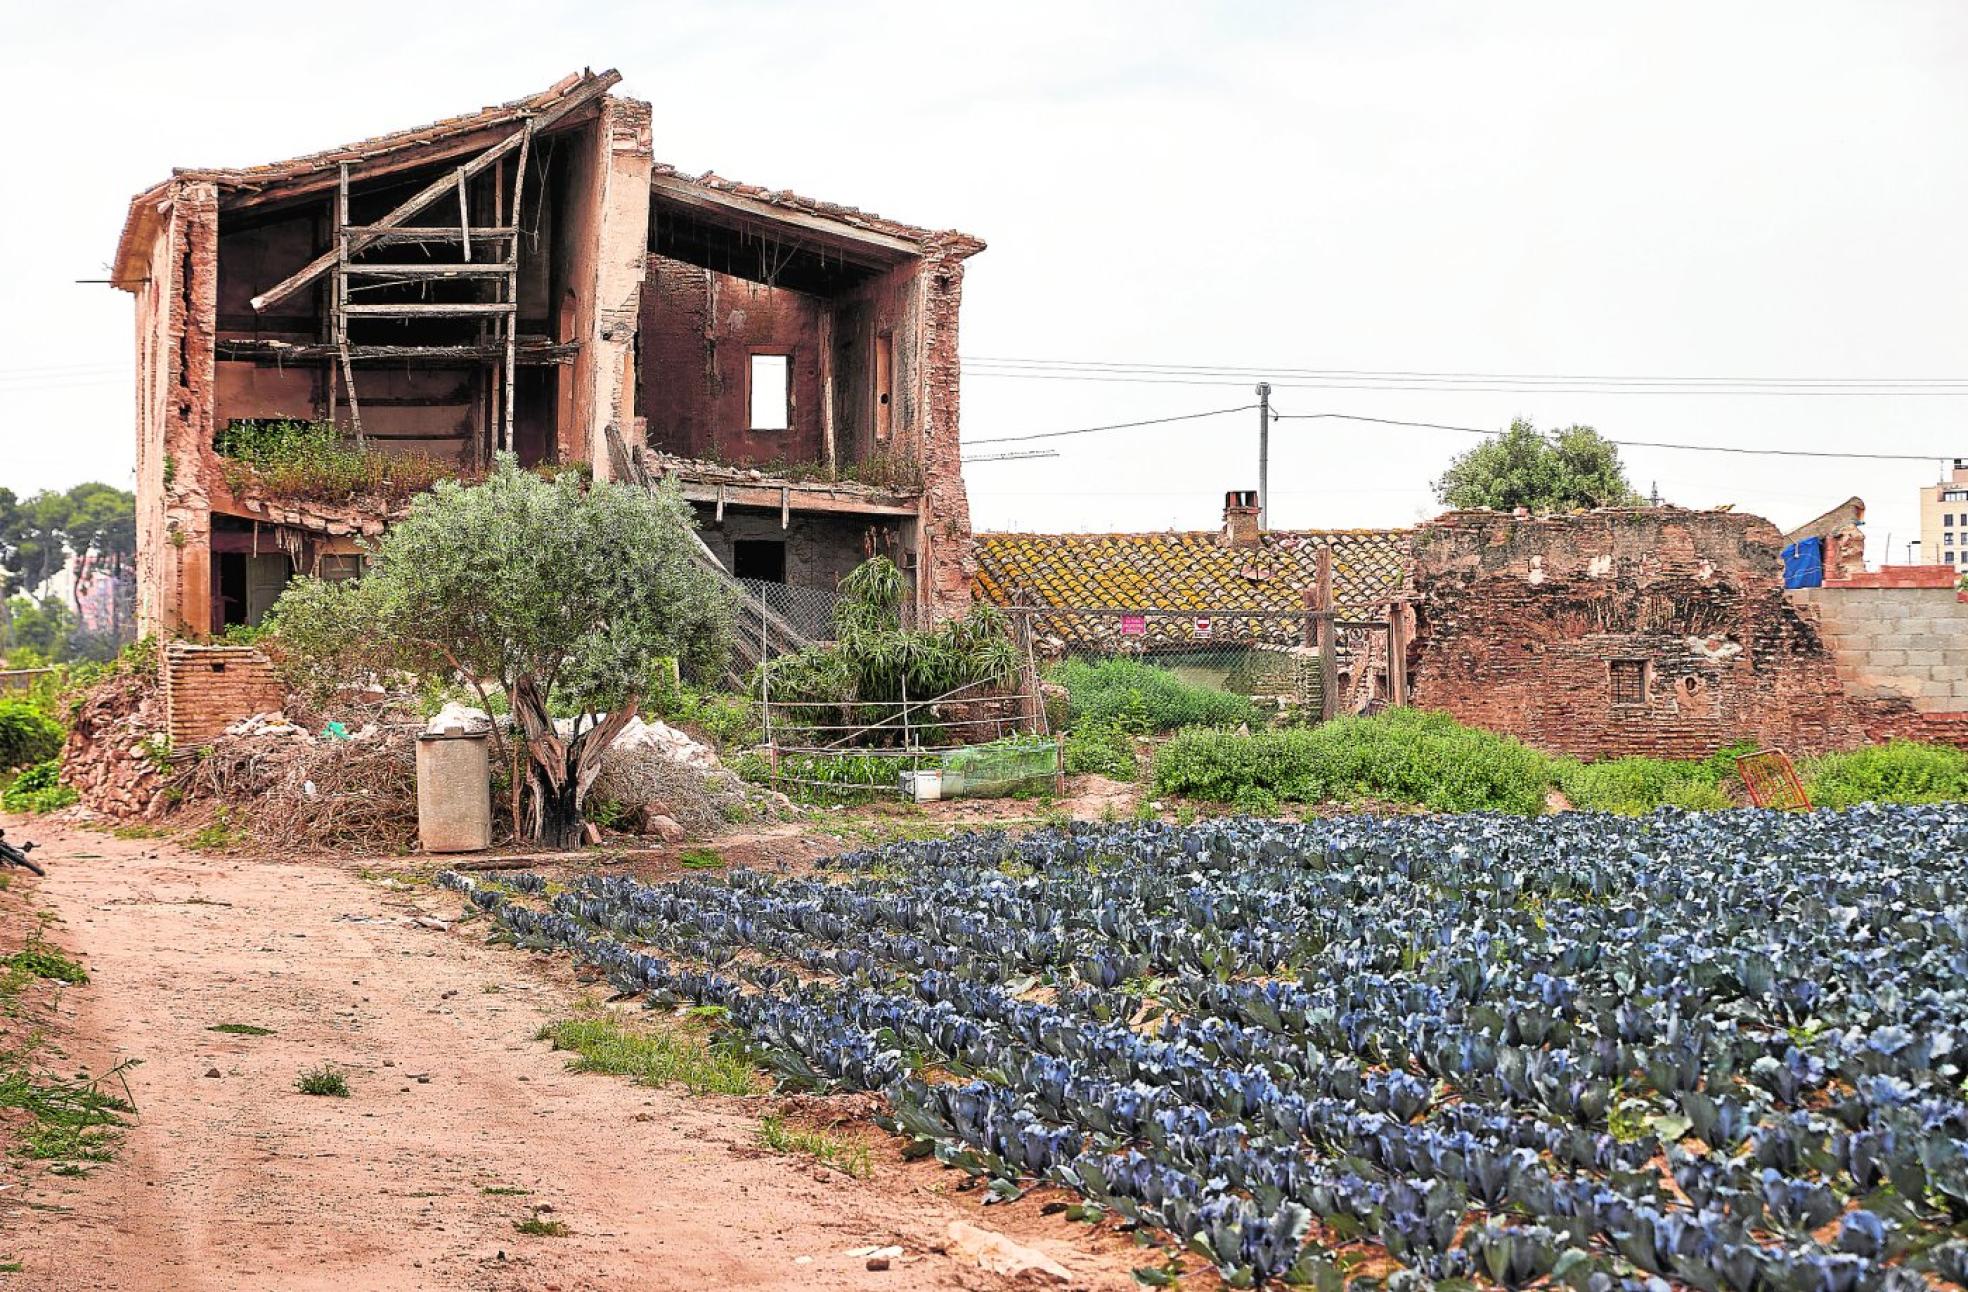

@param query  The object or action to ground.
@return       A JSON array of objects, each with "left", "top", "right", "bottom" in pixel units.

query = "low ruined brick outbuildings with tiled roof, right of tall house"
[{"left": 974, "top": 494, "right": 1968, "bottom": 757}]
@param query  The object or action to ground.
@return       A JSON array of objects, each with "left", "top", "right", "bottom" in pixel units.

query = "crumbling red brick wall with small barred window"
[{"left": 1411, "top": 509, "right": 1864, "bottom": 757}]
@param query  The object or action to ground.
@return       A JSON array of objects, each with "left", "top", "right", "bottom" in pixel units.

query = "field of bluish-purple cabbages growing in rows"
[{"left": 445, "top": 806, "right": 1968, "bottom": 1292}]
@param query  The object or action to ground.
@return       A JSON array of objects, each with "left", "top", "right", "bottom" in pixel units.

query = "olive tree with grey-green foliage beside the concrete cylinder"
[{"left": 274, "top": 456, "right": 732, "bottom": 848}]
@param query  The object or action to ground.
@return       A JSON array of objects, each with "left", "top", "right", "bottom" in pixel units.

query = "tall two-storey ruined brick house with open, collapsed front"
[{"left": 114, "top": 71, "right": 984, "bottom": 635}]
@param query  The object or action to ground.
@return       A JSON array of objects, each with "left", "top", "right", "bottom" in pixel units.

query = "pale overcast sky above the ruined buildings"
[{"left": 0, "top": 0, "right": 1968, "bottom": 560}]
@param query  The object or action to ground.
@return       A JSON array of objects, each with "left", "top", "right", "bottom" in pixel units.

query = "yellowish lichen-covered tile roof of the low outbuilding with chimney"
[{"left": 972, "top": 529, "right": 1411, "bottom": 633}]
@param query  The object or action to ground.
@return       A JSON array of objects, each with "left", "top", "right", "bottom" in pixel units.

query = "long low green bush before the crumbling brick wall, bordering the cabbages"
[{"left": 1155, "top": 710, "right": 1553, "bottom": 814}]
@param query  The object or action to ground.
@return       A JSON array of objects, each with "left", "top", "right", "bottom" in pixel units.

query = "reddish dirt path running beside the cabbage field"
[{"left": 0, "top": 828, "right": 1139, "bottom": 1292}]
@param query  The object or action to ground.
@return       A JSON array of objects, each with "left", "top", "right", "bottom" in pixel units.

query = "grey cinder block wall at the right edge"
[{"left": 1789, "top": 588, "right": 1968, "bottom": 714}]
